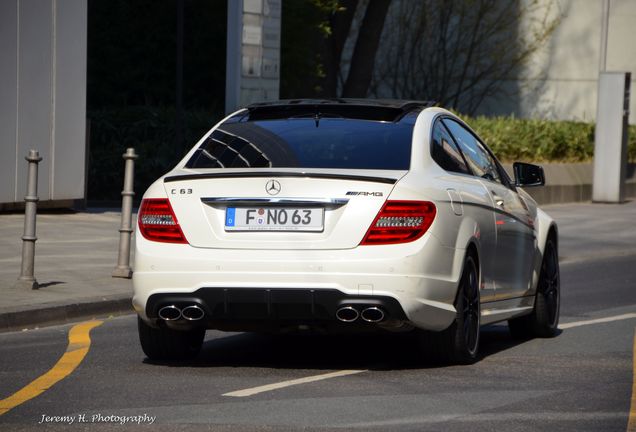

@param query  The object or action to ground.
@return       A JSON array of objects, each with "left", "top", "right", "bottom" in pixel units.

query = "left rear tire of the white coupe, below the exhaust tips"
[{"left": 137, "top": 317, "right": 205, "bottom": 361}]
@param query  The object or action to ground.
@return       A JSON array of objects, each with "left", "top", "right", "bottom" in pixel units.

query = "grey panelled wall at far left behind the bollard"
[{"left": 0, "top": 0, "right": 87, "bottom": 204}]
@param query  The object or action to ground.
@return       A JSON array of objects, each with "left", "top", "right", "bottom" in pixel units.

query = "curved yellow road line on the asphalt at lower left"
[{"left": 0, "top": 321, "right": 103, "bottom": 416}]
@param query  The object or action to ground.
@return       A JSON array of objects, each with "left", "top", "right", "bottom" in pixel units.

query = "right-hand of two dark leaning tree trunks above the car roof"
[{"left": 342, "top": 0, "right": 391, "bottom": 98}]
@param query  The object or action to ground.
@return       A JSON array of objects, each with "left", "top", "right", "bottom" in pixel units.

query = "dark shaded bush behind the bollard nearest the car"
[{"left": 87, "top": 107, "right": 221, "bottom": 201}]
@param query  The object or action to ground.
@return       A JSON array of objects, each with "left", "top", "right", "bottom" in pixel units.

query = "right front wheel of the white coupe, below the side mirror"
[{"left": 508, "top": 238, "right": 561, "bottom": 339}]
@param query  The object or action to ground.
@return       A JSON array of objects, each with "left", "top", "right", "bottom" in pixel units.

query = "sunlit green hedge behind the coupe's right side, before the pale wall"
[{"left": 462, "top": 116, "right": 636, "bottom": 162}]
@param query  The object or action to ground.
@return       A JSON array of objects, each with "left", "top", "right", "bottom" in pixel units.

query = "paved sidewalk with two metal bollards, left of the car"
[{"left": 0, "top": 211, "right": 134, "bottom": 332}]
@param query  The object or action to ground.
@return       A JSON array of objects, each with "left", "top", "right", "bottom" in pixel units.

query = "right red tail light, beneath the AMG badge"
[{"left": 360, "top": 201, "right": 437, "bottom": 245}]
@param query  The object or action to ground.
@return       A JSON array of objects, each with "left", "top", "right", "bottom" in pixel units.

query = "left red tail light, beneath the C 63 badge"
[{"left": 139, "top": 198, "right": 187, "bottom": 243}]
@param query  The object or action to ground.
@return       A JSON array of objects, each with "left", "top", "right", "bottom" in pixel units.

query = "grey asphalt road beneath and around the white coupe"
[{"left": 0, "top": 204, "right": 636, "bottom": 431}]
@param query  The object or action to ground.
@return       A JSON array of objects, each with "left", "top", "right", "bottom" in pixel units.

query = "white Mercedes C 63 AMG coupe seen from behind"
[{"left": 133, "top": 99, "right": 560, "bottom": 364}]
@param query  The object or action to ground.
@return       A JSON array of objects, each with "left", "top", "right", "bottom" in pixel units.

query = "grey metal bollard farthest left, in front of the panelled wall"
[{"left": 15, "top": 150, "right": 42, "bottom": 289}]
